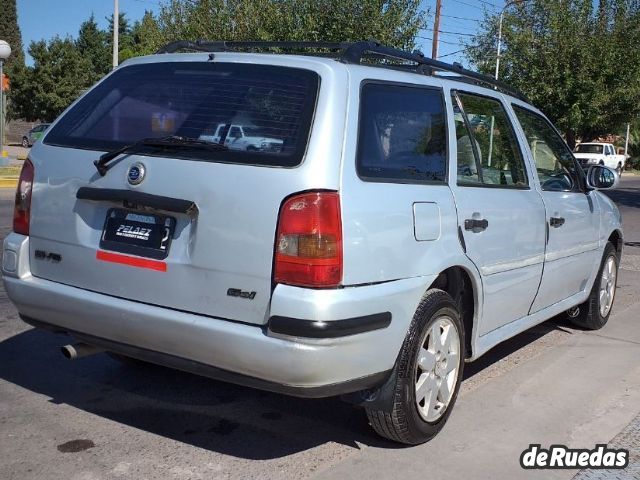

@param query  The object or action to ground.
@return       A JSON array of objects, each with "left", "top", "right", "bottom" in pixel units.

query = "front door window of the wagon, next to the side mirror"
[{"left": 513, "top": 105, "right": 579, "bottom": 192}]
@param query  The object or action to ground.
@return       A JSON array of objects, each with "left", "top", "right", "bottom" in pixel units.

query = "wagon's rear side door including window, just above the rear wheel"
[{"left": 452, "top": 91, "right": 545, "bottom": 335}]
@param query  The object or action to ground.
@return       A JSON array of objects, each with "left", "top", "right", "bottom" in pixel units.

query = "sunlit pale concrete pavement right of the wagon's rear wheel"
[{"left": 319, "top": 302, "right": 640, "bottom": 480}]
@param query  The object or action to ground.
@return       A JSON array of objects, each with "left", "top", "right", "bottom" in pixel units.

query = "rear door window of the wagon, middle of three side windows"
[{"left": 453, "top": 93, "right": 529, "bottom": 188}]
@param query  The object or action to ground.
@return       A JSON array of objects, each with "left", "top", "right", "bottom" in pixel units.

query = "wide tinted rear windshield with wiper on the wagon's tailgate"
[{"left": 45, "top": 62, "right": 319, "bottom": 166}]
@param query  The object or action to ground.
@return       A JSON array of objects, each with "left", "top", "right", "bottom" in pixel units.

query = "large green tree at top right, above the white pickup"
[{"left": 466, "top": 0, "right": 640, "bottom": 144}]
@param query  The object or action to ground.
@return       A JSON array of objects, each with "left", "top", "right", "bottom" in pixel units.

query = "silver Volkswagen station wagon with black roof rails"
[{"left": 2, "top": 41, "right": 623, "bottom": 444}]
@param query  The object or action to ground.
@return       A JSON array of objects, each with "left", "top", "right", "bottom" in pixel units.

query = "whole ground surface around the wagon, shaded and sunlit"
[{"left": 0, "top": 177, "right": 640, "bottom": 480}]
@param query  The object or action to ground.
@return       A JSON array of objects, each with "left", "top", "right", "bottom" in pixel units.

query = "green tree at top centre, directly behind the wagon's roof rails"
[{"left": 158, "top": 0, "right": 426, "bottom": 49}]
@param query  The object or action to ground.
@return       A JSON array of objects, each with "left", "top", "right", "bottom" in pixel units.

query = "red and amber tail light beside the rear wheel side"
[{"left": 274, "top": 192, "right": 342, "bottom": 287}]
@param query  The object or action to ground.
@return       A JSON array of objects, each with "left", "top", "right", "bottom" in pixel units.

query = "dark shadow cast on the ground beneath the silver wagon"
[{"left": 0, "top": 319, "right": 563, "bottom": 460}]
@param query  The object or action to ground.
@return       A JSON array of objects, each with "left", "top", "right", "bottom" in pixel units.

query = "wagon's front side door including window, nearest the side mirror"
[{"left": 514, "top": 105, "right": 600, "bottom": 313}]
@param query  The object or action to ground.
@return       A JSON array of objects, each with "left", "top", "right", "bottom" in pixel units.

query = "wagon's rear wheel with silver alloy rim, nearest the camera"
[{"left": 366, "top": 289, "right": 465, "bottom": 445}]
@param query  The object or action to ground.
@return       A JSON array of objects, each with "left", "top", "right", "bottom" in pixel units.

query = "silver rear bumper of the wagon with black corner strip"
[{"left": 3, "top": 233, "right": 430, "bottom": 397}]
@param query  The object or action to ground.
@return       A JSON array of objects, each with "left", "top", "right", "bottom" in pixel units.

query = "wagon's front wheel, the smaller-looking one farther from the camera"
[{"left": 566, "top": 242, "right": 620, "bottom": 330}]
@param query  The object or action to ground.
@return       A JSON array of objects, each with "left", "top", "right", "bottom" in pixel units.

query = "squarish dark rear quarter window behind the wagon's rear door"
[{"left": 357, "top": 83, "right": 447, "bottom": 183}]
